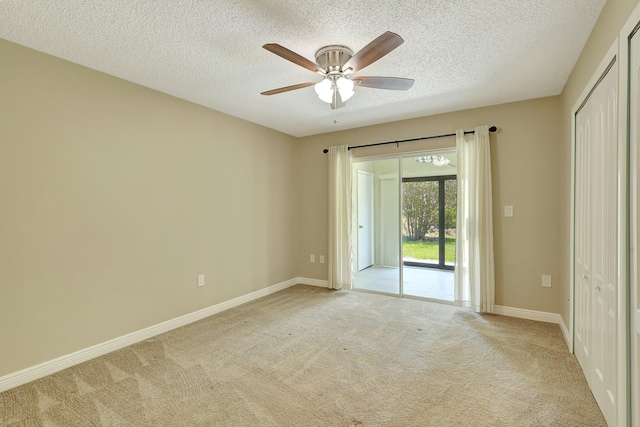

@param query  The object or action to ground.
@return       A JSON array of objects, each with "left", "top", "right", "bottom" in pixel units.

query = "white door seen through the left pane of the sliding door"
[{"left": 358, "top": 170, "right": 374, "bottom": 271}]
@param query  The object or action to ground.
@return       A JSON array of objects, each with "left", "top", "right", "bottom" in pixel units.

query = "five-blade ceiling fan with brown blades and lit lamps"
[{"left": 262, "top": 31, "right": 414, "bottom": 109}]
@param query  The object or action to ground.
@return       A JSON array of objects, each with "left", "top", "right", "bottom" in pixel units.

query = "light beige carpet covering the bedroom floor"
[{"left": 0, "top": 286, "right": 606, "bottom": 427}]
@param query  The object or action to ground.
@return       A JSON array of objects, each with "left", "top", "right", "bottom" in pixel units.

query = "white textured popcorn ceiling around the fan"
[{"left": 0, "top": 0, "right": 605, "bottom": 136}]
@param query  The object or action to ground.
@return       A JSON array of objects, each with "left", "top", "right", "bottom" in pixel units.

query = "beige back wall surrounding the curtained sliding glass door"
[{"left": 296, "top": 97, "right": 566, "bottom": 313}]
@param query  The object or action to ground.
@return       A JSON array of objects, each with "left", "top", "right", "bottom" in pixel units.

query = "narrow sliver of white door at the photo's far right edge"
[{"left": 629, "top": 28, "right": 640, "bottom": 426}]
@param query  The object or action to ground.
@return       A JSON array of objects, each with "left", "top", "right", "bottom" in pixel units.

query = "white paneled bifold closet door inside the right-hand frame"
[{"left": 574, "top": 58, "right": 618, "bottom": 425}]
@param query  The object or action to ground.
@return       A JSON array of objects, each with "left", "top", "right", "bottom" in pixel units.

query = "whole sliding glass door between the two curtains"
[{"left": 352, "top": 152, "right": 457, "bottom": 301}]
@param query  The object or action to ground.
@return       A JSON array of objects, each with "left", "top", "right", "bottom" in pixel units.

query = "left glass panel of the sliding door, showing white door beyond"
[{"left": 352, "top": 159, "right": 400, "bottom": 295}]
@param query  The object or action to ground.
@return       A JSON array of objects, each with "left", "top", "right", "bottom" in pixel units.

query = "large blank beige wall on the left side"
[{"left": 0, "top": 40, "right": 298, "bottom": 376}]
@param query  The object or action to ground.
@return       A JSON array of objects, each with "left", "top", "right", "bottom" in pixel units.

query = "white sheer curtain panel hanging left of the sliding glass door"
[{"left": 329, "top": 145, "right": 353, "bottom": 289}]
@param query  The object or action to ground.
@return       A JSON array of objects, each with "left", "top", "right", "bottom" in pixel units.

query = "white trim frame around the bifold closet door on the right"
[{"left": 572, "top": 38, "right": 628, "bottom": 426}]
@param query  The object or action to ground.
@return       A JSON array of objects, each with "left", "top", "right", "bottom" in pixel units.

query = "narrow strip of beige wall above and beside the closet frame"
[{"left": 559, "top": 0, "right": 639, "bottom": 325}]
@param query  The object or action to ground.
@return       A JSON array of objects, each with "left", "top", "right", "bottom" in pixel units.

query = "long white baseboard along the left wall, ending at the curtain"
[{"left": 0, "top": 277, "right": 302, "bottom": 392}]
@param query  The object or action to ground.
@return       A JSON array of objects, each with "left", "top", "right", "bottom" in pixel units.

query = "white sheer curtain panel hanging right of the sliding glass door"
[{"left": 455, "top": 126, "right": 495, "bottom": 313}]
